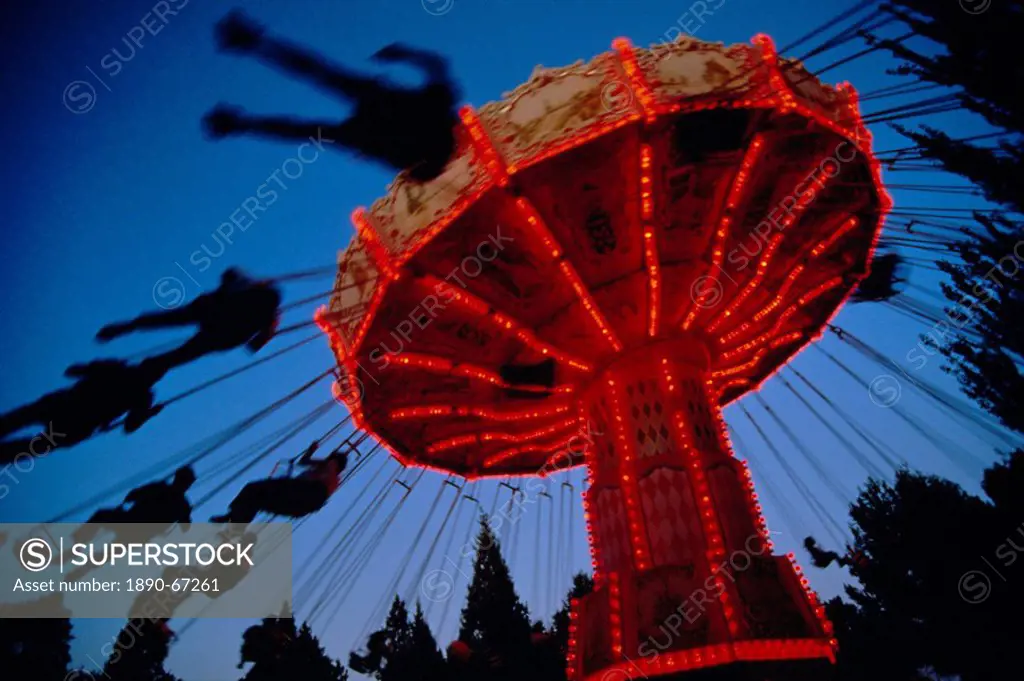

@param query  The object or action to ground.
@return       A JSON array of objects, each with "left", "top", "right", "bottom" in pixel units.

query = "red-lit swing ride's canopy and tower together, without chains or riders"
[{"left": 315, "top": 35, "right": 891, "bottom": 680}]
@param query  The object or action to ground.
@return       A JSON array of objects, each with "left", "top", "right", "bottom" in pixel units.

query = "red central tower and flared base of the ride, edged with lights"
[{"left": 567, "top": 339, "right": 835, "bottom": 681}]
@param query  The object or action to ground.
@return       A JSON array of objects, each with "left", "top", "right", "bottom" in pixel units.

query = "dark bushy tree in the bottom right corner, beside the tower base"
[{"left": 806, "top": 459, "right": 1024, "bottom": 681}]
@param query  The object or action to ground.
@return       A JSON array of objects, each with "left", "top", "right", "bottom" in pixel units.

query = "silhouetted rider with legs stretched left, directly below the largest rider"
[{"left": 96, "top": 267, "right": 281, "bottom": 375}]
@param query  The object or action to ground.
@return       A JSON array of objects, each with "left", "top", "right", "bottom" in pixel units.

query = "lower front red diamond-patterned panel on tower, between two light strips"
[{"left": 639, "top": 468, "right": 703, "bottom": 567}]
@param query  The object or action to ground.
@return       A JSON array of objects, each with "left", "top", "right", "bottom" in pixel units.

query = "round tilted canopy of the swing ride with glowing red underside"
[{"left": 317, "top": 36, "right": 891, "bottom": 477}]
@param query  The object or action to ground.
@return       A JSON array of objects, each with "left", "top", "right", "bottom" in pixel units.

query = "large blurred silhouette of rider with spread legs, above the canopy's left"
[{"left": 204, "top": 11, "right": 459, "bottom": 182}]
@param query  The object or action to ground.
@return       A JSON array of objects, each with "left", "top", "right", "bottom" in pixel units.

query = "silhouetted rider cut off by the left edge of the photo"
[{"left": 0, "top": 359, "right": 164, "bottom": 464}]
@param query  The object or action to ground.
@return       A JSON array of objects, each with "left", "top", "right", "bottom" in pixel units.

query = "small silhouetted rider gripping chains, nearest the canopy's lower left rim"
[{"left": 210, "top": 441, "right": 348, "bottom": 524}]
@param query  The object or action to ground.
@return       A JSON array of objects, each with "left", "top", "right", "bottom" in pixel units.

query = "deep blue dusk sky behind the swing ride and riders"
[{"left": 0, "top": 0, "right": 995, "bottom": 681}]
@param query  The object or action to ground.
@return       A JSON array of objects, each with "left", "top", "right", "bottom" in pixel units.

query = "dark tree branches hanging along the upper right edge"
[{"left": 881, "top": 0, "right": 1024, "bottom": 432}]
